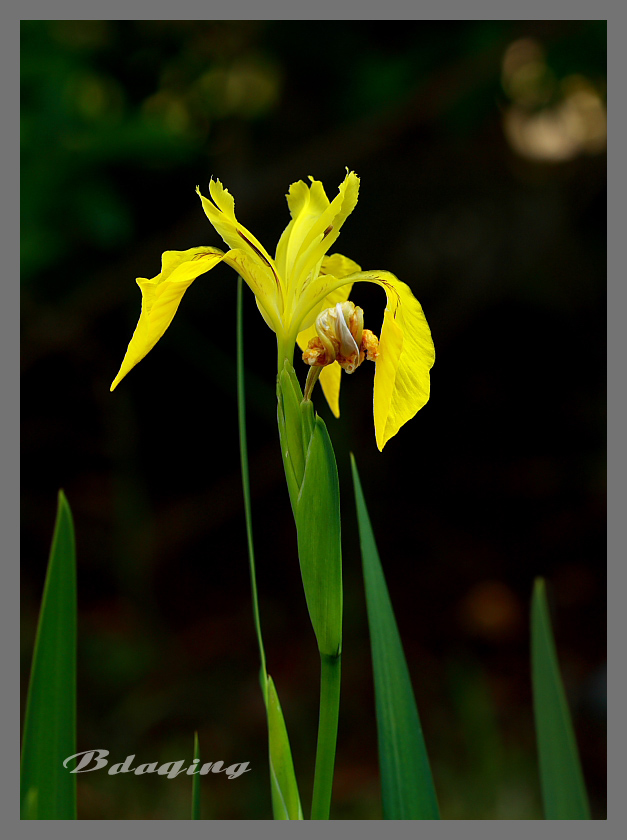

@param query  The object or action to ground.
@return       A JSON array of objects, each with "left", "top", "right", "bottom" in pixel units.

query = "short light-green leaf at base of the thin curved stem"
[{"left": 266, "top": 675, "right": 303, "bottom": 820}]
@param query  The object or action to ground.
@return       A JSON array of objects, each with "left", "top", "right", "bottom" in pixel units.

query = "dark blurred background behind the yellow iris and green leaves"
[{"left": 21, "top": 20, "right": 606, "bottom": 820}]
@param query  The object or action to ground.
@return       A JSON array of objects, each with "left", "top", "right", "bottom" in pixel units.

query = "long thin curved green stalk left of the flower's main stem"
[{"left": 237, "top": 277, "right": 267, "bottom": 684}]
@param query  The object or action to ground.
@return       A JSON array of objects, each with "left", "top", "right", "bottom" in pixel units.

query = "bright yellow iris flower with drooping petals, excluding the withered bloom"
[{"left": 111, "top": 172, "right": 435, "bottom": 450}]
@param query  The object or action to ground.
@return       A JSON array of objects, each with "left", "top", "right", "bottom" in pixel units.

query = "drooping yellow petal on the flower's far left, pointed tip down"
[{"left": 111, "top": 248, "right": 224, "bottom": 391}]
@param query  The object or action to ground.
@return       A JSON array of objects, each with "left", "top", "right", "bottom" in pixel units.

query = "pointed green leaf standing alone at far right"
[{"left": 531, "top": 578, "right": 590, "bottom": 820}]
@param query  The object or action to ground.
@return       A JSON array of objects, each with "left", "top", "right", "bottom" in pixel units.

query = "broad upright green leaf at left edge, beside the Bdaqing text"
[{"left": 21, "top": 491, "right": 76, "bottom": 820}]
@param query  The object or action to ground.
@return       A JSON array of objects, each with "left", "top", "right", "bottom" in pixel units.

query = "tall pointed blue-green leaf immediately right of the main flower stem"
[{"left": 351, "top": 455, "right": 440, "bottom": 820}]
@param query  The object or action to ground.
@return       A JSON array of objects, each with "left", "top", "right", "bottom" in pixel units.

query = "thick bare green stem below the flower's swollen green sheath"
[{"left": 311, "top": 653, "right": 342, "bottom": 820}]
